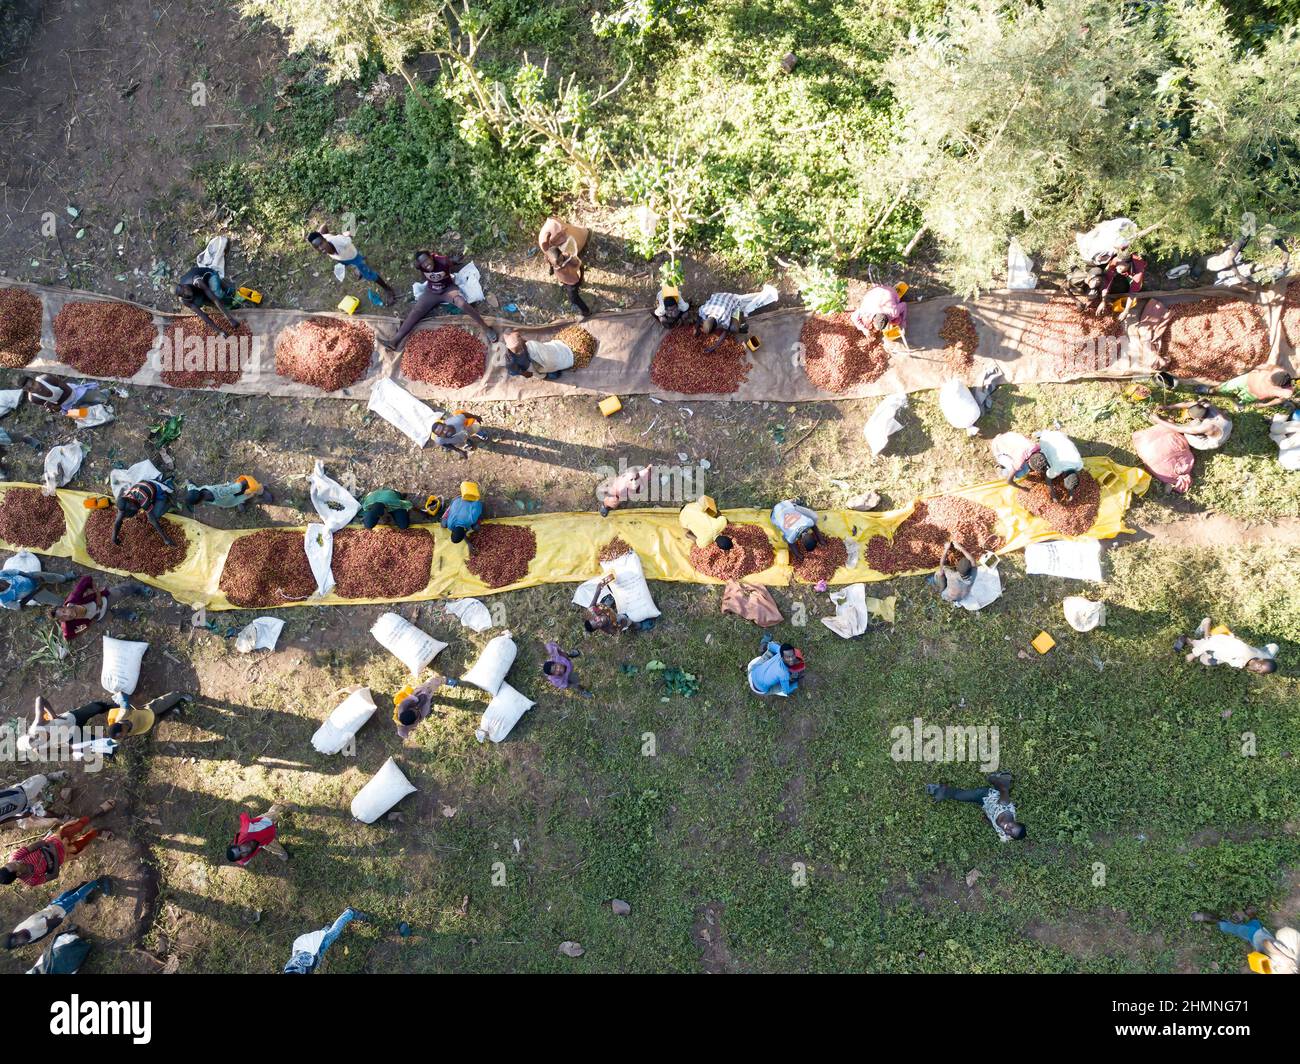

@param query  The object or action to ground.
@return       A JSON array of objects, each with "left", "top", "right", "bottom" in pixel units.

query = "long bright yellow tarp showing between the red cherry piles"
[{"left": 0, "top": 458, "right": 1151, "bottom": 610}]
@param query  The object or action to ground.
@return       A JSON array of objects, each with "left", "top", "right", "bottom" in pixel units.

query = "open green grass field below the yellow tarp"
[{"left": 86, "top": 544, "right": 1300, "bottom": 972}]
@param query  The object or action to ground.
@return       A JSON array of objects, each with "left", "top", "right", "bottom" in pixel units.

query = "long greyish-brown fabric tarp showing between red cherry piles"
[{"left": 0, "top": 278, "right": 1300, "bottom": 405}]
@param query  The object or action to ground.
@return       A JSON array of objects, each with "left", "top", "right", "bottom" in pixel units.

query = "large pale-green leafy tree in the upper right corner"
[{"left": 881, "top": 0, "right": 1300, "bottom": 291}]
